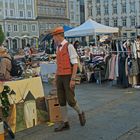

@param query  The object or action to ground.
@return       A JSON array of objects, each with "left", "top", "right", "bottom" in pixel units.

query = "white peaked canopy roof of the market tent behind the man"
[{"left": 65, "top": 19, "right": 119, "bottom": 37}]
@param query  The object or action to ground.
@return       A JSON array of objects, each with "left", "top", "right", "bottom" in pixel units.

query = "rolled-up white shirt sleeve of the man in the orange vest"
[{"left": 68, "top": 44, "right": 78, "bottom": 64}]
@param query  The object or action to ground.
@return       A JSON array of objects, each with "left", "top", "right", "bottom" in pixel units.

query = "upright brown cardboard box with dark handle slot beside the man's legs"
[{"left": 46, "top": 95, "right": 62, "bottom": 122}]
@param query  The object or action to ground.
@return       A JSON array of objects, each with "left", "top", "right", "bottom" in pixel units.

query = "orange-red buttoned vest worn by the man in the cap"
[{"left": 56, "top": 43, "right": 72, "bottom": 75}]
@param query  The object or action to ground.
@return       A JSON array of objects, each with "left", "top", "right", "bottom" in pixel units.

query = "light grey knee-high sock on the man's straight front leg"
[{"left": 60, "top": 106, "right": 68, "bottom": 122}]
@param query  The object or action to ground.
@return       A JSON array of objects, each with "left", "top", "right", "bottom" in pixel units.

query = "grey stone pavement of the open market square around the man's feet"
[{"left": 7, "top": 83, "right": 140, "bottom": 140}]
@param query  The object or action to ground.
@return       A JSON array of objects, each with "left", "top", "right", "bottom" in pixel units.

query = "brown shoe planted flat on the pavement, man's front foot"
[{"left": 54, "top": 122, "right": 70, "bottom": 132}]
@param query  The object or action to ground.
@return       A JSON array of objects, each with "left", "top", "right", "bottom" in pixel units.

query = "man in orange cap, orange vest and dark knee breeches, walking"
[{"left": 52, "top": 27, "right": 86, "bottom": 132}]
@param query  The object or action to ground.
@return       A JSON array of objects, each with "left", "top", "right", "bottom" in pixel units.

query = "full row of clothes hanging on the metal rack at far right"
[{"left": 104, "top": 39, "right": 140, "bottom": 88}]
